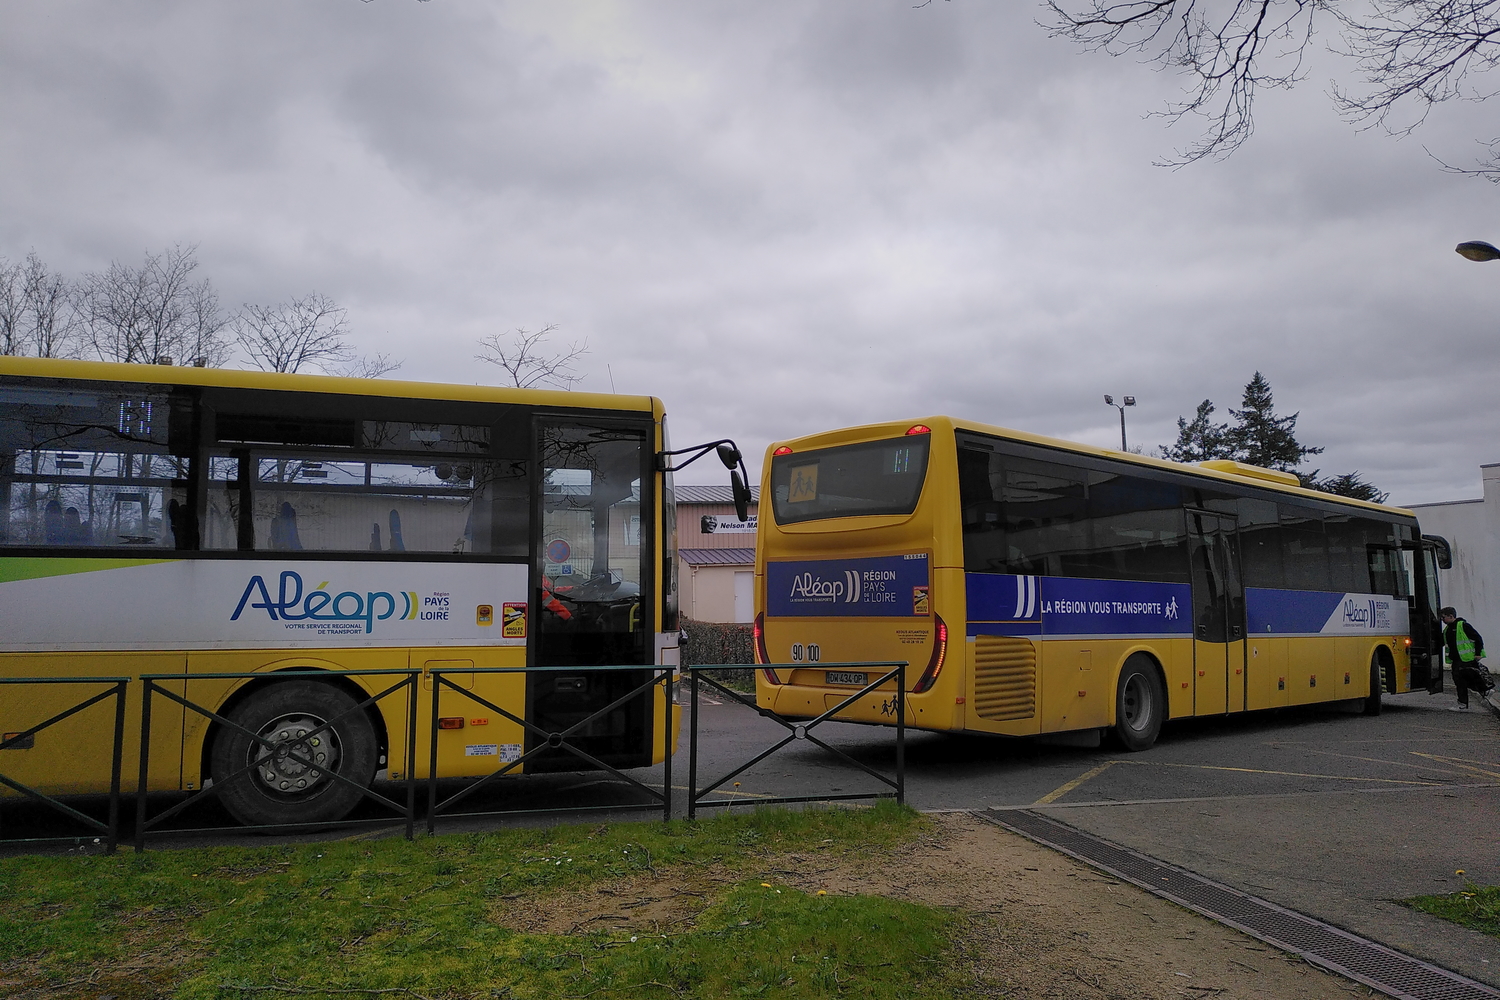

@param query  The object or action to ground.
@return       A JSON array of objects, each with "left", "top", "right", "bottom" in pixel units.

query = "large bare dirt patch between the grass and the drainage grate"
[{"left": 777, "top": 813, "right": 1374, "bottom": 1000}]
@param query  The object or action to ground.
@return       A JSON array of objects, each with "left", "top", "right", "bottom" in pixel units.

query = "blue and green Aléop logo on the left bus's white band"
[{"left": 230, "top": 570, "right": 450, "bottom": 634}]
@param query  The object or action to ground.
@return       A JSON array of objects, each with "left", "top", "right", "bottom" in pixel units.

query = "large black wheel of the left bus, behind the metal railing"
[{"left": 209, "top": 681, "right": 380, "bottom": 826}]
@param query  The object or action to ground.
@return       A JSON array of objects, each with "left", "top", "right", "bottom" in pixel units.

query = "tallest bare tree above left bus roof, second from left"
[{"left": 77, "top": 244, "right": 233, "bottom": 366}]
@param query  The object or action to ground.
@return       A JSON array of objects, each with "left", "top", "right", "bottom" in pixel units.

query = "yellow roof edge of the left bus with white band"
[{"left": 0, "top": 357, "right": 663, "bottom": 418}]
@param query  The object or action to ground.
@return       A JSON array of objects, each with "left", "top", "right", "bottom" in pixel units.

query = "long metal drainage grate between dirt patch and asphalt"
[{"left": 978, "top": 810, "right": 1500, "bottom": 1000}]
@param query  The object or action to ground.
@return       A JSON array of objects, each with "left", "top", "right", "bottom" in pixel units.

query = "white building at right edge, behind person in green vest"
[{"left": 1409, "top": 463, "right": 1500, "bottom": 632}]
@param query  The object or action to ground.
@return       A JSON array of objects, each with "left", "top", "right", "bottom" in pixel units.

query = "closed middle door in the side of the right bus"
[{"left": 1188, "top": 510, "right": 1245, "bottom": 715}]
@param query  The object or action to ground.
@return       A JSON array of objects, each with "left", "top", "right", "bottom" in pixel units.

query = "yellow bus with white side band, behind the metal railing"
[{"left": 0, "top": 357, "right": 707, "bottom": 825}]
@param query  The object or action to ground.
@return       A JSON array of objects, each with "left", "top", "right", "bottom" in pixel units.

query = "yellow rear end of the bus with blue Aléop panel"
[{"left": 756, "top": 421, "right": 963, "bottom": 729}]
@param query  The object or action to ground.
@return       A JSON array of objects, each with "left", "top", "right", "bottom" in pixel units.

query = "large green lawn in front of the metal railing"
[{"left": 0, "top": 804, "right": 962, "bottom": 1000}]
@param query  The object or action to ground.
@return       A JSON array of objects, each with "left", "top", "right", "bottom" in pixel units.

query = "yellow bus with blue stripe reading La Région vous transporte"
[{"left": 755, "top": 417, "right": 1442, "bottom": 750}]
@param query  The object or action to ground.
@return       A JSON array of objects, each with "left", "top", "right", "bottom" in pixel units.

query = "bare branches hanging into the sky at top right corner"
[{"left": 1044, "top": 0, "right": 1500, "bottom": 170}]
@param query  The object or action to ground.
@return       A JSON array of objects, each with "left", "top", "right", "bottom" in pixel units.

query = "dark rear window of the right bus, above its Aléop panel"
[{"left": 771, "top": 435, "right": 930, "bottom": 525}]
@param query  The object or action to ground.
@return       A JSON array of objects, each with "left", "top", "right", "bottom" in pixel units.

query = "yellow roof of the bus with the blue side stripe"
[{"left": 767, "top": 417, "right": 1416, "bottom": 517}]
